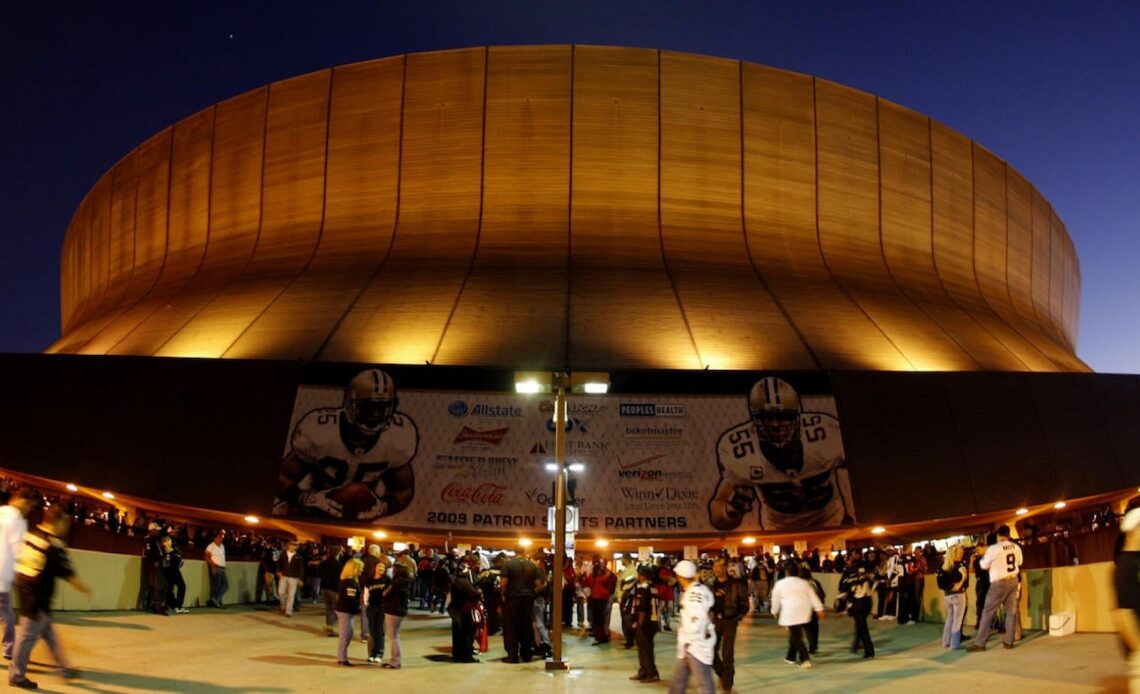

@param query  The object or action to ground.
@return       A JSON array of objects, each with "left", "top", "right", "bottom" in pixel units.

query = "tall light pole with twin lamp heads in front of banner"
[{"left": 515, "top": 372, "right": 610, "bottom": 671}]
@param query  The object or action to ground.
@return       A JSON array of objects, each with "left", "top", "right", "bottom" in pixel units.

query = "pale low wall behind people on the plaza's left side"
[{"left": 52, "top": 549, "right": 259, "bottom": 610}]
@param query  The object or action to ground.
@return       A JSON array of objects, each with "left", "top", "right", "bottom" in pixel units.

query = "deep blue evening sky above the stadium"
[{"left": 0, "top": 0, "right": 1140, "bottom": 374}]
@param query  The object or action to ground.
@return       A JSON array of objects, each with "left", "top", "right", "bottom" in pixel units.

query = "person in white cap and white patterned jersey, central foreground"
[{"left": 669, "top": 560, "right": 716, "bottom": 694}]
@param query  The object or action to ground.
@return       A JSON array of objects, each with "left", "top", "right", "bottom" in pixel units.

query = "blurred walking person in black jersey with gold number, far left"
[{"left": 8, "top": 504, "right": 93, "bottom": 689}]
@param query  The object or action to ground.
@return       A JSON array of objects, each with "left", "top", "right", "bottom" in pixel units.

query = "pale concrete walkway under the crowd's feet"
[{"left": 11, "top": 605, "right": 1127, "bottom": 694}]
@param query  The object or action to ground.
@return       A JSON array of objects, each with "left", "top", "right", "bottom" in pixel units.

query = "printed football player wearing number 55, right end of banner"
[{"left": 709, "top": 376, "right": 855, "bottom": 531}]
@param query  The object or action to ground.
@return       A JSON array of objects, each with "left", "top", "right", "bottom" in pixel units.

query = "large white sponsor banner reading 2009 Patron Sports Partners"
[{"left": 274, "top": 369, "right": 855, "bottom": 537}]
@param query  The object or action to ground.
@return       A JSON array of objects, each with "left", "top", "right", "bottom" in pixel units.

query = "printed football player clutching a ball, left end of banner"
[{"left": 274, "top": 369, "right": 420, "bottom": 521}]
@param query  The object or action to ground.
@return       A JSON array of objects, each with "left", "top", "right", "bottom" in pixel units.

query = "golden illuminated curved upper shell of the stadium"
[{"left": 49, "top": 46, "right": 1086, "bottom": 372}]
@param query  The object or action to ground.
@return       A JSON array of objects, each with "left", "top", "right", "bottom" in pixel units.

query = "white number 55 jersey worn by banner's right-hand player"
[{"left": 717, "top": 413, "right": 855, "bottom": 531}]
